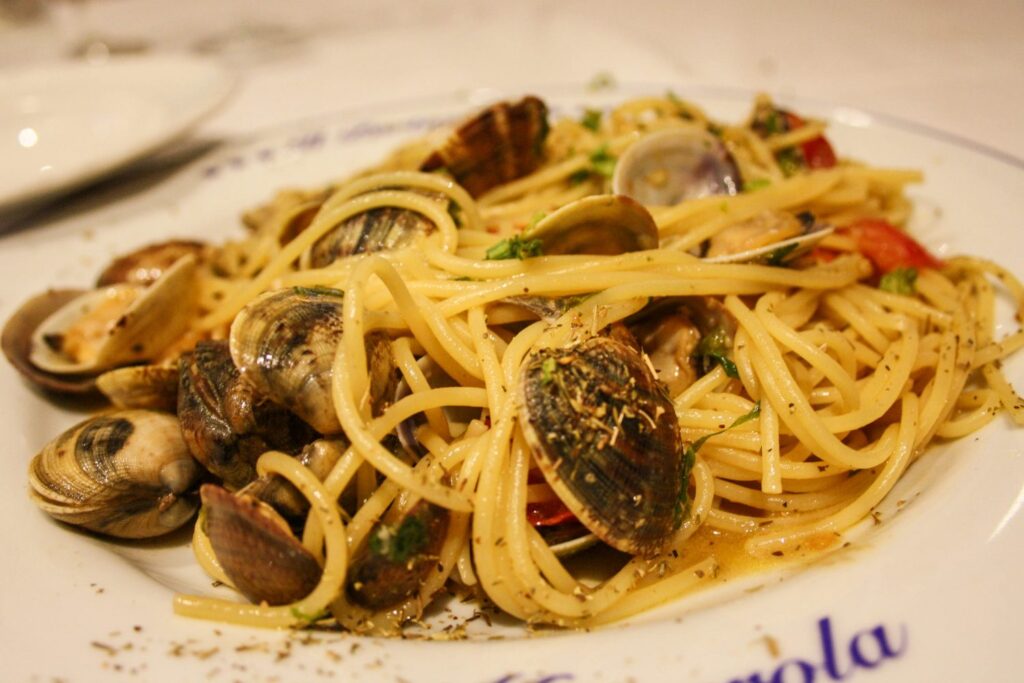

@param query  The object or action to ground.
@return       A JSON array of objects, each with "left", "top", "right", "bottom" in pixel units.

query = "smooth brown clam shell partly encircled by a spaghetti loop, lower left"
[{"left": 201, "top": 484, "right": 323, "bottom": 605}]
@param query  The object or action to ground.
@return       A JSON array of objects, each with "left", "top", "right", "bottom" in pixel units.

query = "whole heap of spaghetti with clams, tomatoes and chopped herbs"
[{"left": 4, "top": 90, "right": 1024, "bottom": 633}]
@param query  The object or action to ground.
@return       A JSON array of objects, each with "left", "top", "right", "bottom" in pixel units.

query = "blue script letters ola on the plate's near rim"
[{"left": 729, "top": 616, "right": 908, "bottom": 683}]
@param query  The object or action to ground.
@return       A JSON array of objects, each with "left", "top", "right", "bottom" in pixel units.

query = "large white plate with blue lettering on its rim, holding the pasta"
[{"left": 0, "top": 86, "right": 1024, "bottom": 683}]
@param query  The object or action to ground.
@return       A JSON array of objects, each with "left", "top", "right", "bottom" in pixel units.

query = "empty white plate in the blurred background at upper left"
[{"left": 0, "top": 55, "right": 233, "bottom": 209}]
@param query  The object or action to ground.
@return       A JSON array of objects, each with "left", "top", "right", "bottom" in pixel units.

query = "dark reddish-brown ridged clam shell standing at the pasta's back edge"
[{"left": 420, "top": 96, "right": 549, "bottom": 197}]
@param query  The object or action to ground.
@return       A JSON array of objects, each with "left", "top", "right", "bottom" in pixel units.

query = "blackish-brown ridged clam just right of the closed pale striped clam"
[{"left": 177, "top": 341, "right": 315, "bottom": 488}]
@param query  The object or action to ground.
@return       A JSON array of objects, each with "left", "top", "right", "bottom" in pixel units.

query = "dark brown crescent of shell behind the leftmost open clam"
[{"left": 0, "top": 290, "right": 96, "bottom": 394}]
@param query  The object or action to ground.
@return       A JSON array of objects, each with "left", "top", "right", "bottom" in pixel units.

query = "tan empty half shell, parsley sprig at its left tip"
[{"left": 522, "top": 195, "right": 657, "bottom": 255}]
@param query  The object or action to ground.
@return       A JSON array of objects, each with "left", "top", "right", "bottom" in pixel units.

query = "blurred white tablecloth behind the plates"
[{"left": 0, "top": 0, "right": 1024, "bottom": 158}]
